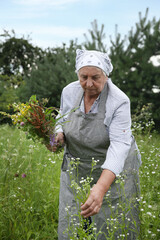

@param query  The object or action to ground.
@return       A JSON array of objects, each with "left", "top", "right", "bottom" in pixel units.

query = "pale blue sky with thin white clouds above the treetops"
[{"left": 0, "top": 0, "right": 160, "bottom": 49}]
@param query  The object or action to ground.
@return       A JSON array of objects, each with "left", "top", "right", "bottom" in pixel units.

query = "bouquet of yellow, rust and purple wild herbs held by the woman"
[{"left": 0, "top": 95, "right": 63, "bottom": 150}]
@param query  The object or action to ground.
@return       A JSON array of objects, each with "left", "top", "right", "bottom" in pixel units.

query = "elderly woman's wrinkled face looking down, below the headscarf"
[{"left": 78, "top": 66, "right": 107, "bottom": 97}]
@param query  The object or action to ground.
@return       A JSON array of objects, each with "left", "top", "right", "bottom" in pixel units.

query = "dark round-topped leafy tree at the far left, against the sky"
[{"left": 0, "top": 30, "right": 43, "bottom": 76}]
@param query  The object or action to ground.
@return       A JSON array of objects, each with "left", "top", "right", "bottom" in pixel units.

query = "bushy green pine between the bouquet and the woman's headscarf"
[{"left": 19, "top": 41, "right": 77, "bottom": 107}]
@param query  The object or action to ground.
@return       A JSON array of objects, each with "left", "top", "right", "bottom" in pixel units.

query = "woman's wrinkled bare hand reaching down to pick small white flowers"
[{"left": 81, "top": 184, "right": 105, "bottom": 218}]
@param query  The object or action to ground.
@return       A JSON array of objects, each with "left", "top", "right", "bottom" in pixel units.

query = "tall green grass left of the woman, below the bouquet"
[{"left": 0, "top": 126, "right": 62, "bottom": 240}]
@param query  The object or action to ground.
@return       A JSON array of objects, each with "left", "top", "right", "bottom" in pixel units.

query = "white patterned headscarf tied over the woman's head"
[{"left": 76, "top": 49, "right": 113, "bottom": 76}]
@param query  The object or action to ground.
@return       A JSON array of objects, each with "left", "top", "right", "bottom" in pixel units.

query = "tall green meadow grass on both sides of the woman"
[{"left": 0, "top": 125, "right": 160, "bottom": 240}]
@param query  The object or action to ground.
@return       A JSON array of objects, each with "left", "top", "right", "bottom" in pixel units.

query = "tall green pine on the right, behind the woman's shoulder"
[{"left": 110, "top": 9, "right": 160, "bottom": 127}]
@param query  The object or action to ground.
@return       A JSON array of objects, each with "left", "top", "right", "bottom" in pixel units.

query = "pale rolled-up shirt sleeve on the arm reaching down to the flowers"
[{"left": 101, "top": 99, "right": 132, "bottom": 175}]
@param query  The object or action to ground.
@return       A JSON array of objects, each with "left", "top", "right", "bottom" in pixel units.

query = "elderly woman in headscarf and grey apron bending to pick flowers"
[{"left": 56, "top": 49, "right": 140, "bottom": 240}]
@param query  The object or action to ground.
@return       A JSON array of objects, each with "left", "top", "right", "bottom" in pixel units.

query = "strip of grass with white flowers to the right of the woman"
[{"left": 137, "top": 134, "right": 160, "bottom": 240}]
